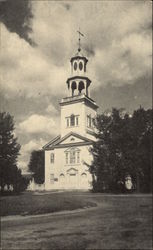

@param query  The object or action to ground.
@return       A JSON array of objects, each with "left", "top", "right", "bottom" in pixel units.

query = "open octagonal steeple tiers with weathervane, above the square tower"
[{"left": 67, "top": 30, "right": 91, "bottom": 97}]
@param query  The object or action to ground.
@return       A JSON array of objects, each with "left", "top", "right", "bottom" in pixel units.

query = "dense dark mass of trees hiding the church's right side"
[{"left": 89, "top": 108, "right": 152, "bottom": 192}]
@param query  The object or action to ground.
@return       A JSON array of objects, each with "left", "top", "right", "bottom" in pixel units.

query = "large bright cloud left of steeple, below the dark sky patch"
[{"left": 0, "top": 25, "right": 67, "bottom": 98}]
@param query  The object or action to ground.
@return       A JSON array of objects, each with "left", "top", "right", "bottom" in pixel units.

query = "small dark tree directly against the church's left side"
[{"left": 28, "top": 150, "right": 45, "bottom": 184}]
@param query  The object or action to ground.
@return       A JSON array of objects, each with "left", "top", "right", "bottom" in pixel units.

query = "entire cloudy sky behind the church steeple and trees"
[{"left": 0, "top": 0, "right": 152, "bottom": 172}]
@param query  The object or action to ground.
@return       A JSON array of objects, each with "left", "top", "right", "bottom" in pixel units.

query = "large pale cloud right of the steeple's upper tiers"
[{"left": 90, "top": 28, "right": 152, "bottom": 88}]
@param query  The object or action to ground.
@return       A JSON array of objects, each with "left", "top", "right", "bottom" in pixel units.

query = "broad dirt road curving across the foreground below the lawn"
[{"left": 1, "top": 195, "right": 152, "bottom": 250}]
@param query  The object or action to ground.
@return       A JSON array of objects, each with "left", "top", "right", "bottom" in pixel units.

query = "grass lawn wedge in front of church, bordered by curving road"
[{"left": 0, "top": 192, "right": 96, "bottom": 216}]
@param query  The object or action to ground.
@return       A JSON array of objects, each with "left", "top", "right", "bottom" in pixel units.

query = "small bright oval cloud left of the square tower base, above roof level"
[{"left": 19, "top": 114, "right": 59, "bottom": 135}]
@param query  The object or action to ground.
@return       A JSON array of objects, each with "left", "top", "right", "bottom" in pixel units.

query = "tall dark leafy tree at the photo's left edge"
[{"left": 0, "top": 112, "right": 20, "bottom": 192}]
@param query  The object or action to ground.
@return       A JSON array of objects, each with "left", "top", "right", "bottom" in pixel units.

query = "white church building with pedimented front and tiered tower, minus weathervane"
[{"left": 43, "top": 45, "right": 98, "bottom": 190}]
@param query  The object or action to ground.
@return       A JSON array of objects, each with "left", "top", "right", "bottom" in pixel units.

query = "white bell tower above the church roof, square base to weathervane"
[{"left": 60, "top": 30, "right": 98, "bottom": 140}]
